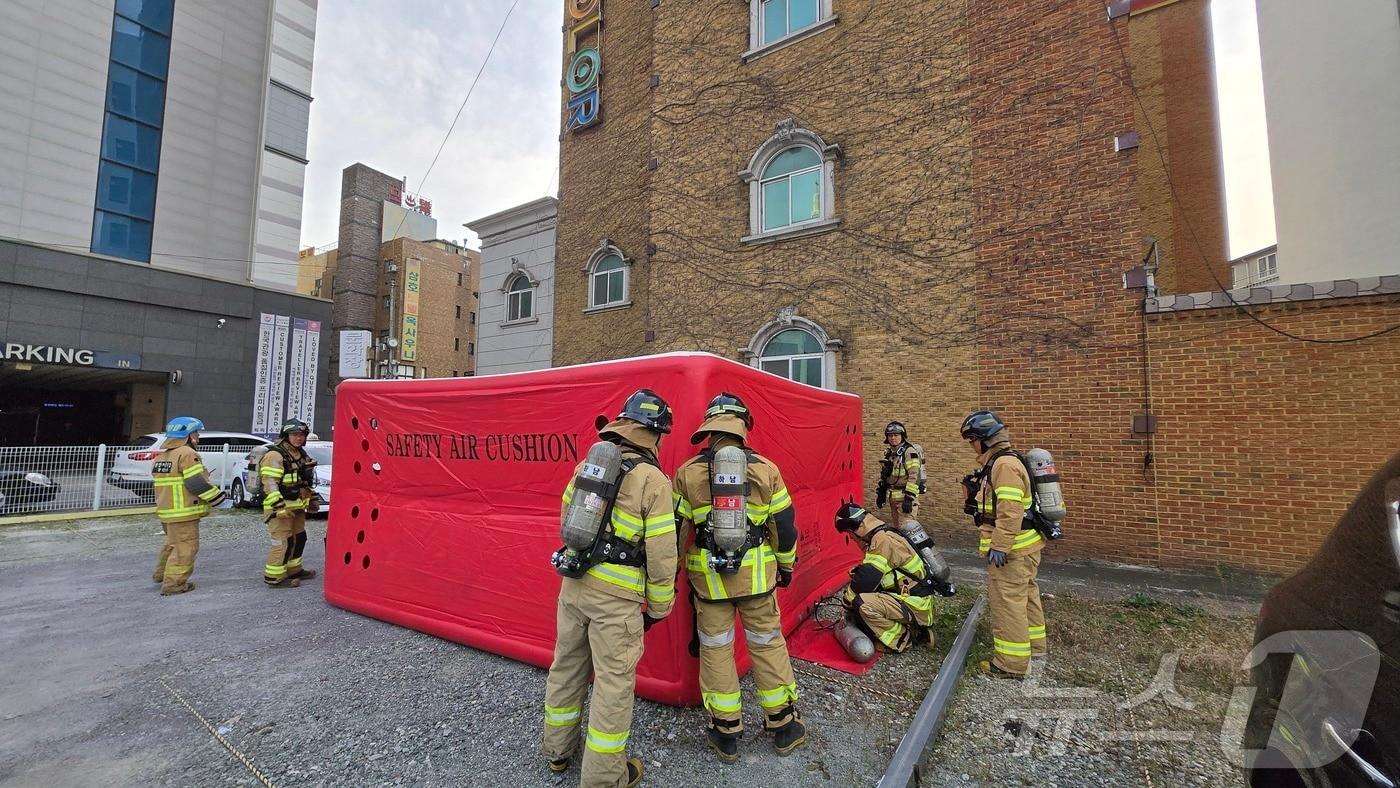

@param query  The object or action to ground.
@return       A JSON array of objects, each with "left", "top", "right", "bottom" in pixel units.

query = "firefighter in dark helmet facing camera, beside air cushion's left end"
[{"left": 258, "top": 418, "right": 319, "bottom": 588}]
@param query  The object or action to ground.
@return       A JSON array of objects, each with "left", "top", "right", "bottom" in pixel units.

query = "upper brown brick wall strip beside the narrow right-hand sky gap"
[{"left": 1123, "top": 0, "right": 1231, "bottom": 293}]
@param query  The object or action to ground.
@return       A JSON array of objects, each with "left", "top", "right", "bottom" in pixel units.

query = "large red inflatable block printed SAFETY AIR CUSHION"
[{"left": 325, "top": 353, "right": 861, "bottom": 704}]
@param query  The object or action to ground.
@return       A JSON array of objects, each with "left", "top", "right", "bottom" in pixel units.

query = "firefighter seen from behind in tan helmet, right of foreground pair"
[{"left": 676, "top": 393, "right": 806, "bottom": 763}]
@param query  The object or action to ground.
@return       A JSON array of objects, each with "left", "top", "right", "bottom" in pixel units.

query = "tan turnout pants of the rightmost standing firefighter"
[{"left": 987, "top": 553, "right": 1046, "bottom": 675}]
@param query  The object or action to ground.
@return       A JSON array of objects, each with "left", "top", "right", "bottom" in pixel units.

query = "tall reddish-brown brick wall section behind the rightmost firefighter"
[{"left": 969, "top": 0, "right": 1155, "bottom": 561}]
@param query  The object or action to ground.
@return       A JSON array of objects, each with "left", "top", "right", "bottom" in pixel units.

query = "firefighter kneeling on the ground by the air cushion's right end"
[{"left": 836, "top": 502, "right": 956, "bottom": 661}]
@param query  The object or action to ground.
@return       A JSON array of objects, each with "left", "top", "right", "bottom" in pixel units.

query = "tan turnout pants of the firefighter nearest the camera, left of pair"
[{"left": 543, "top": 578, "right": 643, "bottom": 788}]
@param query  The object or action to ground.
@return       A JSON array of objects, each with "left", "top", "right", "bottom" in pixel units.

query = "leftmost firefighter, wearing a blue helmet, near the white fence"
[{"left": 151, "top": 416, "right": 224, "bottom": 596}]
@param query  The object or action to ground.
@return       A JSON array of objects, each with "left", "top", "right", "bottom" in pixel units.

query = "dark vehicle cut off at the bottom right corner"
[{"left": 1245, "top": 453, "right": 1400, "bottom": 788}]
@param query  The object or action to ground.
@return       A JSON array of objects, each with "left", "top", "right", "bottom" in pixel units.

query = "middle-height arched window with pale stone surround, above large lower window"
[{"left": 739, "top": 120, "right": 840, "bottom": 242}]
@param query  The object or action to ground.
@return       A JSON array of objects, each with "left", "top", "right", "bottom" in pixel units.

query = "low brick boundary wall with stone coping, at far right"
[{"left": 1148, "top": 286, "right": 1400, "bottom": 572}]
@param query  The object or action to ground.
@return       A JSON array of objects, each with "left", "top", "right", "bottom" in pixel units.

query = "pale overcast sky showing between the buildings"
[{"left": 301, "top": 0, "right": 1274, "bottom": 256}]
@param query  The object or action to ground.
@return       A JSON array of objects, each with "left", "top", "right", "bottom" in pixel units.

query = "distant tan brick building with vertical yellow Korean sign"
[{"left": 375, "top": 238, "right": 482, "bottom": 378}]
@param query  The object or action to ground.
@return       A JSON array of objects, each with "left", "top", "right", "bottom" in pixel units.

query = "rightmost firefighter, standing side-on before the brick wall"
[{"left": 962, "top": 410, "right": 1046, "bottom": 679}]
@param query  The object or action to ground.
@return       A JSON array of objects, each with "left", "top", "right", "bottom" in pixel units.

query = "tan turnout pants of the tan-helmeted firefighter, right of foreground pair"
[{"left": 694, "top": 593, "right": 797, "bottom": 735}]
